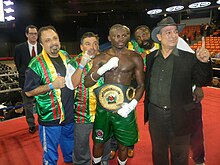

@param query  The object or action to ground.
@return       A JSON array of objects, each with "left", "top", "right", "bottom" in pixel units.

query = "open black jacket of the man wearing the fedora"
[{"left": 144, "top": 50, "right": 212, "bottom": 135}]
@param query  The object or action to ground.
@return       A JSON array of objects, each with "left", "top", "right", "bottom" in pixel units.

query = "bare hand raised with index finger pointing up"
[{"left": 196, "top": 37, "right": 210, "bottom": 63}]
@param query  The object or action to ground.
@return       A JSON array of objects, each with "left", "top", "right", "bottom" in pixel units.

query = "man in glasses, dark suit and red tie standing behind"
[{"left": 14, "top": 25, "right": 42, "bottom": 133}]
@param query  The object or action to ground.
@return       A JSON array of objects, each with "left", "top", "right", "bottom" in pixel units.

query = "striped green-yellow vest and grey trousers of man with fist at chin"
[{"left": 69, "top": 53, "right": 109, "bottom": 165}]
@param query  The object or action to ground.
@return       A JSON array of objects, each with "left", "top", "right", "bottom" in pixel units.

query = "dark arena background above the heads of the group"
[{"left": 0, "top": 0, "right": 219, "bottom": 57}]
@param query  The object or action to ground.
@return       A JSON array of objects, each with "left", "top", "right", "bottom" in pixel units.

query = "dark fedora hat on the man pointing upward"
[{"left": 151, "top": 17, "right": 185, "bottom": 43}]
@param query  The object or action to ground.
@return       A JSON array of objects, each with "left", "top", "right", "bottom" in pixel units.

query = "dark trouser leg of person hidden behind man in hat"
[{"left": 190, "top": 102, "right": 205, "bottom": 164}]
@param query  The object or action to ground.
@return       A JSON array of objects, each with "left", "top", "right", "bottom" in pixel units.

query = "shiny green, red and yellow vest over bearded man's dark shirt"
[{"left": 25, "top": 50, "right": 73, "bottom": 125}]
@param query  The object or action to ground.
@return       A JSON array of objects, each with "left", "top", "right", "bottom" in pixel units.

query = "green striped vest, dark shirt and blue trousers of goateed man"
[{"left": 24, "top": 50, "right": 74, "bottom": 164}]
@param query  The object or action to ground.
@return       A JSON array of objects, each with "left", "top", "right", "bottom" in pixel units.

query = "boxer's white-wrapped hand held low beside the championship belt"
[{"left": 117, "top": 99, "right": 138, "bottom": 118}]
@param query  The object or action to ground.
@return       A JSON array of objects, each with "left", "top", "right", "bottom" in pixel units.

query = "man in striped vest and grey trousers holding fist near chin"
[{"left": 65, "top": 32, "right": 110, "bottom": 165}]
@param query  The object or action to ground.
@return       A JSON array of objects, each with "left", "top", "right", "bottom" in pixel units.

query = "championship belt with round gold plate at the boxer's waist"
[{"left": 94, "top": 84, "right": 135, "bottom": 112}]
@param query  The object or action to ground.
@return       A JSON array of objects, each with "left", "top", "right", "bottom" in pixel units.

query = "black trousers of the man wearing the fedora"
[{"left": 148, "top": 104, "right": 190, "bottom": 165}]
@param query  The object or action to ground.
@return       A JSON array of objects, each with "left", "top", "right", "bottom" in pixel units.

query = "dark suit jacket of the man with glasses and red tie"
[{"left": 14, "top": 42, "right": 42, "bottom": 89}]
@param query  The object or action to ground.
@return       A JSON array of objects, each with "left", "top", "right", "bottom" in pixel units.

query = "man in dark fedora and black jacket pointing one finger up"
[{"left": 144, "top": 17, "right": 212, "bottom": 165}]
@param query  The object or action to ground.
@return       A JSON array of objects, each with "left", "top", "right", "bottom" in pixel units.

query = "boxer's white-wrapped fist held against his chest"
[{"left": 97, "top": 57, "right": 119, "bottom": 76}]
